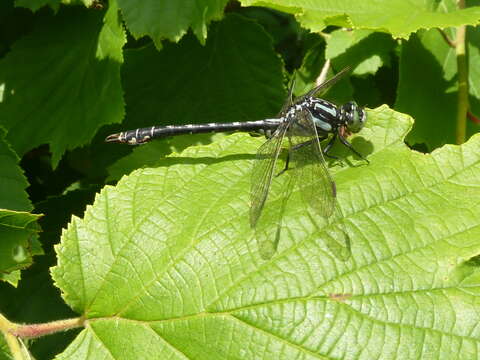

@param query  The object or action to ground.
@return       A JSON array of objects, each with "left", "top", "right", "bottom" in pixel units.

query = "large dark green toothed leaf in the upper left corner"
[{"left": 0, "top": 1, "right": 125, "bottom": 165}]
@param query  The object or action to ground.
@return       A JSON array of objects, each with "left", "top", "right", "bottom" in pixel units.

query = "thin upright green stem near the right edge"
[{"left": 455, "top": 0, "right": 468, "bottom": 144}]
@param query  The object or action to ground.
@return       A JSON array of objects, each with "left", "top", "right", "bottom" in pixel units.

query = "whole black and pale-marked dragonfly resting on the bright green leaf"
[{"left": 105, "top": 67, "right": 368, "bottom": 260}]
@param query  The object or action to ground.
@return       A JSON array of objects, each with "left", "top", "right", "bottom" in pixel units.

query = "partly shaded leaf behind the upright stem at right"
[{"left": 395, "top": 29, "right": 480, "bottom": 149}]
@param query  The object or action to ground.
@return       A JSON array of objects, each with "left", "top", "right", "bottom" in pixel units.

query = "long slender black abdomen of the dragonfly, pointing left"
[{"left": 105, "top": 119, "right": 281, "bottom": 145}]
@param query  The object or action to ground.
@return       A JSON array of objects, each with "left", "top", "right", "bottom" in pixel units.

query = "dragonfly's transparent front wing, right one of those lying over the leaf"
[{"left": 288, "top": 109, "right": 350, "bottom": 260}]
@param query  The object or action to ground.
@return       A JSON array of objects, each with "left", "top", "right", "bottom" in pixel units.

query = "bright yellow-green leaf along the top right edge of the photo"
[{"left": 241, "top": 0, "right": 480, "bottom": 38}]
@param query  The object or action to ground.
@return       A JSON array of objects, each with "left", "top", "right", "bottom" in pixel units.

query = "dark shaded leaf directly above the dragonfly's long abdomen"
[{"left": 122, "top": 15, "right": 285, "bottom": 135}]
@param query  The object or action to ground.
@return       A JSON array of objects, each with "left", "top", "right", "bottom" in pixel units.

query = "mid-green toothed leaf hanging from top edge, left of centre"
[{"left": 118, "top": 0, "right": 227, "bottom": 48}]
